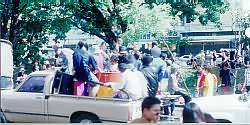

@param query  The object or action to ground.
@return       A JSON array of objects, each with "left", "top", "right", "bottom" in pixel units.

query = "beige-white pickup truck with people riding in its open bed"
[{"left": 1, "top": 71, "right": 142, "bottom": 123}]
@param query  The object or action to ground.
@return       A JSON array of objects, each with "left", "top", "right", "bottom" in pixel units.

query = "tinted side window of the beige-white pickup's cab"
[{"left": 18, "top": 76, "right": 46, "bottom": 93}]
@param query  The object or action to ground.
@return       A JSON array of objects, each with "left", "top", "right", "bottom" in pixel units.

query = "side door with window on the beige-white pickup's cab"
[{"left": 3, "top": 76, "right": 46, "bottom": 122}]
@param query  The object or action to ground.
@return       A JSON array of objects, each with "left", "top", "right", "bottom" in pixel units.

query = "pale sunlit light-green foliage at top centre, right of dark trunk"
[{"left": 120, "top": 2, "right": 179, "bottom": 44}]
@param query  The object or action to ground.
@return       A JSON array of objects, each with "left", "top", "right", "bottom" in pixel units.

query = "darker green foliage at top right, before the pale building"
[{"left": 145, "top": 0, "right": 229, "bottom": 28}]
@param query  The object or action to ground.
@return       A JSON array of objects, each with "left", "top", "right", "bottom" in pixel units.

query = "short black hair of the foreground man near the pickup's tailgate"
[{"left": 141, "top": 96, "right": 161, "bottom": 112}]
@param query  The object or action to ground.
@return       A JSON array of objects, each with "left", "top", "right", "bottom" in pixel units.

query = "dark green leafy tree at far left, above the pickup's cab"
[{"left": 1, "top": 0, "right": 72, "bottom": 71}]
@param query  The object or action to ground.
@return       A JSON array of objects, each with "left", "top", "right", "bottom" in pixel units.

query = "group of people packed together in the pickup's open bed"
[{"left": 34, "top": 38, "right": 191, "bottom": 102}]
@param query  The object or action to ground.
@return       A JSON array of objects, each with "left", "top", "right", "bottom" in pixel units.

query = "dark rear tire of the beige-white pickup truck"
[{"left": 71, "top": 113, "right": 101, "bottom": 123}]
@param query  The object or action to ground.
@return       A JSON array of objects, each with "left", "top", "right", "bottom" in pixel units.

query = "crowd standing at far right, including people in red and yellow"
[{"left": 188, "top": 47, "right": 250, "bottom": 97}]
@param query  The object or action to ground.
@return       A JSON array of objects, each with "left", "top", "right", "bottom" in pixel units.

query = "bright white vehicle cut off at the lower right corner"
[{"left": 193, "top": 94, "right": 250, "bottom": 124}]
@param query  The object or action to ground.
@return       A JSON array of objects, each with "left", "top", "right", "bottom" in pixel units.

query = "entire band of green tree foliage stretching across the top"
[{"left": 0, "top": 0, "right": 230, "bottom": 72}]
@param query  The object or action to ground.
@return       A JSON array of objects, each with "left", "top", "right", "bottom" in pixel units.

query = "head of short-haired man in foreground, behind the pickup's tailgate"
[{"left": 141, "top": 97, "right": 161, "bottom": 122}]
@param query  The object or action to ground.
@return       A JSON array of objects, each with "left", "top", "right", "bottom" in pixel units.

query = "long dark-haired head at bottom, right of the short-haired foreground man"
[{"left": 182, "top": 102, "right": 205, "bottom": 123}]
